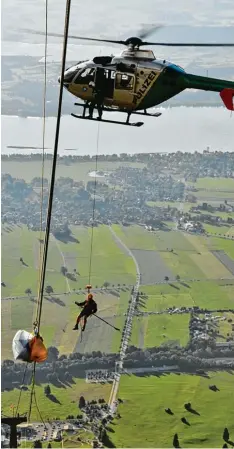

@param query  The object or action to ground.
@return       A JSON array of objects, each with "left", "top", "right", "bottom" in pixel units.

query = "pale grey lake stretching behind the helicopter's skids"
[{"left": 1, "top": 106, "right": 234, "bottom": 155}]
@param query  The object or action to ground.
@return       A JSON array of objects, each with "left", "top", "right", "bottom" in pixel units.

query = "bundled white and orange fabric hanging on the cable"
[{"left": 12, "top": 330, "right": 48, "bottom": 363}]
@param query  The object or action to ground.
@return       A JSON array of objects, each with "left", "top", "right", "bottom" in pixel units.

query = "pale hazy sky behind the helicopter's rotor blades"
[{"left": 2, "top": 0, "right": 234, "bottom": 64}]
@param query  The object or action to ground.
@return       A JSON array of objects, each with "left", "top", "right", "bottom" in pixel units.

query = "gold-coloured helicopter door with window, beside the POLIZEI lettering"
[{"left": 113, "top": 72, "right": 135, "bottom": 107}]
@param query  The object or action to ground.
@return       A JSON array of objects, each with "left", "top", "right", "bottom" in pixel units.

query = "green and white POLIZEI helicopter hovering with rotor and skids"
[{"left": 26, "top": 27, "right": 234, "bottom": 127}]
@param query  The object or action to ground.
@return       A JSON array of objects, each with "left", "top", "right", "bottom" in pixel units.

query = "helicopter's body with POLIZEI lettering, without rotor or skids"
[{"left": 61, "top": 49, "right": 234, "bottom": 112}]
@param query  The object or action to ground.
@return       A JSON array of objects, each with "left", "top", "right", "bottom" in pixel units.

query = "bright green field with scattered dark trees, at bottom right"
[{"left": 109, "top": 373, "right": 234, "bottom": 448}]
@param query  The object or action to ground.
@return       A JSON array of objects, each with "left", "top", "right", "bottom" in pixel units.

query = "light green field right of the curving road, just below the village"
[{"left": 112, "top": 225, "right": 234, "bottom": 280}]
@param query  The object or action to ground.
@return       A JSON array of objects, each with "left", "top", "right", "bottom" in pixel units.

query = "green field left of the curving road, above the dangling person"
[{"left": 2, "top": 226, "right": 135, "bottom": 296}]
